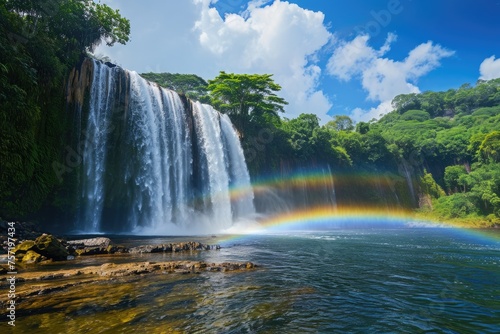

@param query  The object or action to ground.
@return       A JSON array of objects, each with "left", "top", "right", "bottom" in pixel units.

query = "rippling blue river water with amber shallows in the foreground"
[{"left": 7, "top": 229, "right": 500, "bottom": 333}]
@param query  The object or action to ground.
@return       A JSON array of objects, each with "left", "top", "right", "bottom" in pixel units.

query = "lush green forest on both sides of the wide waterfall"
[{"left": 0, "top": 0, "right": 500, "bottom": 226}]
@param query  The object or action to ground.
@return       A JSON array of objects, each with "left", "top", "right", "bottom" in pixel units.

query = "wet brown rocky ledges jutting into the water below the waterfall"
[{"left": 0, "top": 221, "right": 257, "bottom": 304}]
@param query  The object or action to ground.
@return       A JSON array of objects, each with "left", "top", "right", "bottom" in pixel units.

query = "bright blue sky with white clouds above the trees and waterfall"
[{"left": 96, "top": 0, "right": 500, "bottom": 123}]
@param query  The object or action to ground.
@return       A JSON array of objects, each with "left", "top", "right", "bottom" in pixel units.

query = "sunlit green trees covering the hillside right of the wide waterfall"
[{"left": 149, "top": 72, "right": 500, "bottom": 224}]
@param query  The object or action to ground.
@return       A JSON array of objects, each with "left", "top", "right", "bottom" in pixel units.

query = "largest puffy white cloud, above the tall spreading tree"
[{"left": 194, "top": 0, "right": 332, "bottom": 122}]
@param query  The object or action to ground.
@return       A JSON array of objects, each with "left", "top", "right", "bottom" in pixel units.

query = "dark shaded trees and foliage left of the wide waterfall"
[{"left": 0, "top": 0, "right": 130, "bottom": 219}]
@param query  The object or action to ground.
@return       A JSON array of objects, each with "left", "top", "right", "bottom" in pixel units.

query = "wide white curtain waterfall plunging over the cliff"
[{"left": 77, "top": 61, "right": 255, "bottom": 234}]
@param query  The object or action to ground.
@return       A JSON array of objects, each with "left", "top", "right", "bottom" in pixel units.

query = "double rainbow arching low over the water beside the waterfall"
[{"left": 209, "top": 169, "right": 500, "bottom": 242}]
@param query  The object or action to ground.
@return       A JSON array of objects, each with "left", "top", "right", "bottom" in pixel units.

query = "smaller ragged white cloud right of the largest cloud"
[{"left": 327, "top": 34, "right": 454, "bottom": 121}]
